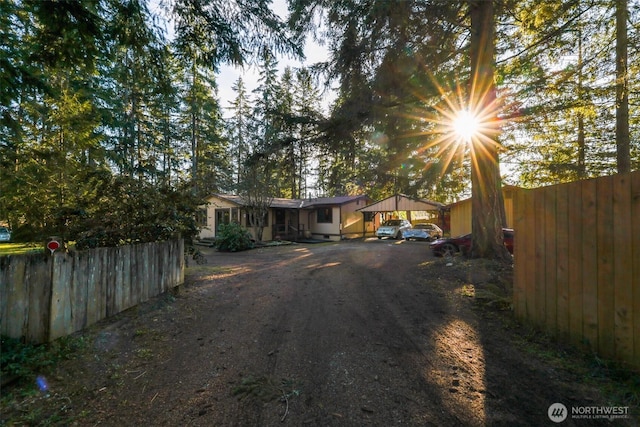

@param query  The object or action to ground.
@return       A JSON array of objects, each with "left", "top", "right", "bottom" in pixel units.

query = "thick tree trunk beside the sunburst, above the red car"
[{"left": 469, "top": 0, "right": 510, "bottom": 259}]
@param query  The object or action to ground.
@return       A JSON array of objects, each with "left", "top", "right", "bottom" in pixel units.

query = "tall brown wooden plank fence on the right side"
[{"left": 514, "top": 171, "right": 640, "bottom": 370}]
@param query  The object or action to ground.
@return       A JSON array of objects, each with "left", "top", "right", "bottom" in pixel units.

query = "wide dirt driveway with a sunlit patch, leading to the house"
[{"left": 6, "top": 240, "right": 636, "bottom": 426}]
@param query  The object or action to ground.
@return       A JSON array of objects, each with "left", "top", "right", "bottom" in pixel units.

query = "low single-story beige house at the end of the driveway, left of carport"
[{"left": 198, "top": 194, "right": 377, "bottom": 240}]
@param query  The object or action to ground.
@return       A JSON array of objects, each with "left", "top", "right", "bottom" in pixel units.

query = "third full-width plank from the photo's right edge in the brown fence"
[{"left": 578, "top": 179, "right": 599, "bottom": 351}]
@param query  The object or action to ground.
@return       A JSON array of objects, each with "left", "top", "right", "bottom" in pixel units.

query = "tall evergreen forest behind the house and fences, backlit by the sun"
[{"left": 0, "top": 0, "right": 640, "bottom": 247}]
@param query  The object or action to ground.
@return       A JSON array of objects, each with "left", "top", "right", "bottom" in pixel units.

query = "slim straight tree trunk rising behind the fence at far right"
[{"left": 616, "top": 0, "right": 631, "bottom": 173}]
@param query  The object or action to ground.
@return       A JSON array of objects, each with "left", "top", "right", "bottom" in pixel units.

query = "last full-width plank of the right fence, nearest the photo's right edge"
[{"left": 611, "top": 174, "right": 634, "bottom": 368}]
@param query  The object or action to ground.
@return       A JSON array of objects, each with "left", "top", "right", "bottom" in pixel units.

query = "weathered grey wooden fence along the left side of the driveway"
[{"left": 0, "top": 239, "right": 184, "bottom": 343}]
